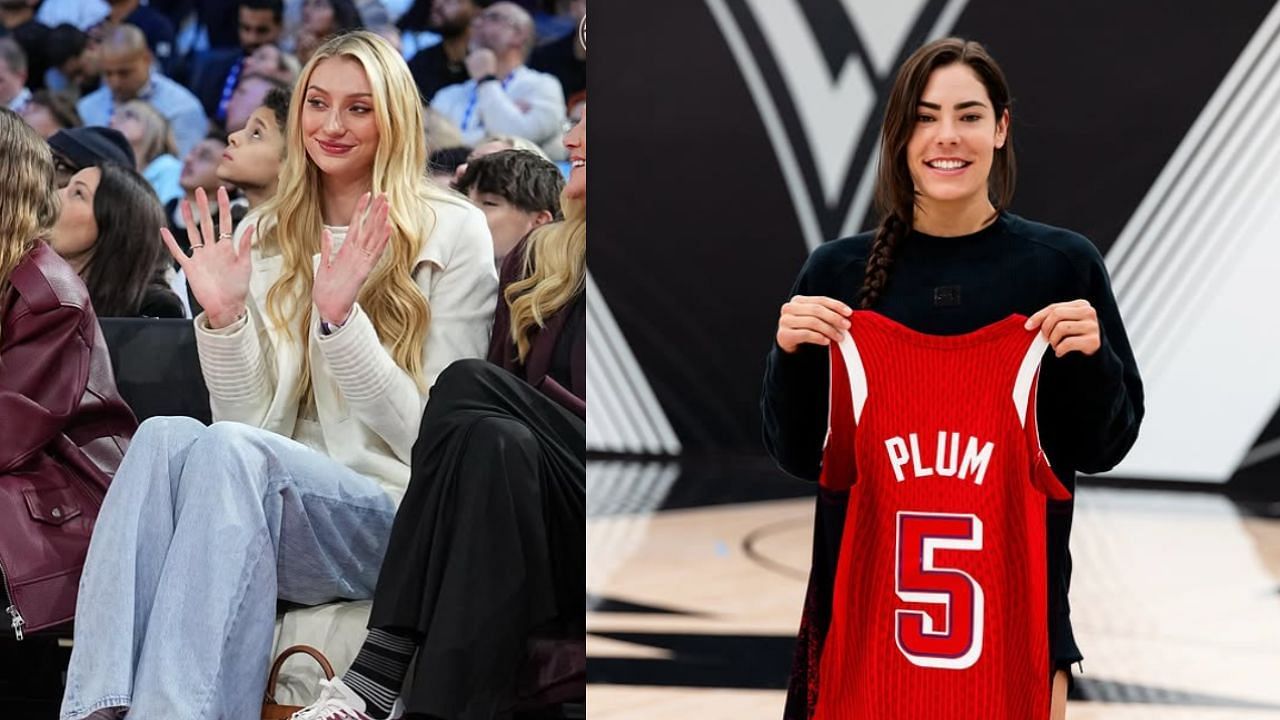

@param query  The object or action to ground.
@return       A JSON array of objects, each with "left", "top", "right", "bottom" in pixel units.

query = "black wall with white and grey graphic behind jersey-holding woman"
[{"left": 589, "top": 0, "right": 1280, "bottom": 483}]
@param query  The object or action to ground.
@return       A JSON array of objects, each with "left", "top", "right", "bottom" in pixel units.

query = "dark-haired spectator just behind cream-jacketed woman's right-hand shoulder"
[{"left": 453, "top": 150, "right": 564, "bottom": 268}]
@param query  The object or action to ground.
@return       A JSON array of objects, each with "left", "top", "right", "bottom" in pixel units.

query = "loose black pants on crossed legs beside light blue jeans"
[{"left": 370, "top": 360, "right": 586, "bottom": 720}]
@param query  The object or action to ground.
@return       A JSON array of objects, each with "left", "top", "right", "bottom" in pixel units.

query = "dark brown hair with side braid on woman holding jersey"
[{"left": 858, "top": 37, "right": 1016, "bottom": 309}]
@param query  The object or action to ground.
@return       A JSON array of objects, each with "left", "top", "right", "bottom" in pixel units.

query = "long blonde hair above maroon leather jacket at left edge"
[{"left": 0, "top": 108, "right": 61, "bottom": 316}]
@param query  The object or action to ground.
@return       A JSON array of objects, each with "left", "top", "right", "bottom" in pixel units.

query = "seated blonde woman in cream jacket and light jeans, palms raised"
[{"left": 61, "top": 32, "right": 497, "bottom": 720}]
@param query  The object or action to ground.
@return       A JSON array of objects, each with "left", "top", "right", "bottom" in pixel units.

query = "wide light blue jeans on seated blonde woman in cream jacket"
[{"left": 61, "top": 418, "right": 396, "bottom": 720}]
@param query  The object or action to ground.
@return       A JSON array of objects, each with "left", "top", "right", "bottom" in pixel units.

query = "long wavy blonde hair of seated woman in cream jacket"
[{"left": 260, "top": 31, "right": 453, "bottom": 398}]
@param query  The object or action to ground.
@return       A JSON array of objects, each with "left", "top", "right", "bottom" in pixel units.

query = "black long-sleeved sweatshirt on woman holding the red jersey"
[{"left": 760, "top": 213, "right": 1143, "bottom": 666}]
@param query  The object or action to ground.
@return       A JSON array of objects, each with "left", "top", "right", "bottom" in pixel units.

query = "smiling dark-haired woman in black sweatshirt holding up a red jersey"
[{"left": 762, "top": 38, "right": 1143, "bottom": 720}]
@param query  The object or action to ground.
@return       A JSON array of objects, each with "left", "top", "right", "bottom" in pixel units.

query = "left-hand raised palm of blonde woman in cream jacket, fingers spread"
[{"left": 160, "top": 187, "right": 253, "bottom": 329}]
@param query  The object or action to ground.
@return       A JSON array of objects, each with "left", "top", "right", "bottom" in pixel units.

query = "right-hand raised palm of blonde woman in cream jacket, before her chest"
[{"left": 311, "top": 192, "right": 392, "bottom": 325}]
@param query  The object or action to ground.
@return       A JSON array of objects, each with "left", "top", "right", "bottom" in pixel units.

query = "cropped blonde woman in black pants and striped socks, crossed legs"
[{"left": 294, "top": 105, "right": 586, "bottom": 720}]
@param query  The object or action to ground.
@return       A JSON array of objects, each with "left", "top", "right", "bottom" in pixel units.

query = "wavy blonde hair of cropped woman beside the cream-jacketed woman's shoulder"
[{"left": 504, "top": 193, "right": 586, "bottom": 363}]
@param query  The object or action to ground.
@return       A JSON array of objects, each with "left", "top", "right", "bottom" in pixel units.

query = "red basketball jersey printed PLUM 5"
[{"left": 814, "top": 311, "right": 1069, "bottom": 720}]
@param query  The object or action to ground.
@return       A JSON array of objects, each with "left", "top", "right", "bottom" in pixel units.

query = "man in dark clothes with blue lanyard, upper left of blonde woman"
[{"left": 192, "top": 0, "right": 284, "bottom": 123}]
